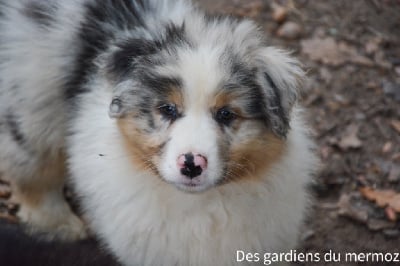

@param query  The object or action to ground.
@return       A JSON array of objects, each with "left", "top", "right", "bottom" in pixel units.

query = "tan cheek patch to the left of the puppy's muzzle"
[{"left": 117, "top": 116, "right": 161, "bottom": 175}]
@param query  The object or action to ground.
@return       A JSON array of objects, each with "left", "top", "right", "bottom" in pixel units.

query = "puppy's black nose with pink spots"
[{"left": 178, "top": 152, "right": 207, "bottom": 178}]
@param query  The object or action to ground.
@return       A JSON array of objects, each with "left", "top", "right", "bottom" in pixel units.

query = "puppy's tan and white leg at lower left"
[{"left": 11, "top": 153, "right": 86, "bottom": 241}]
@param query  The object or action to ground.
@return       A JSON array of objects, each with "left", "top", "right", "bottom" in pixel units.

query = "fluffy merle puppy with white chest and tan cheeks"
[{"left": 0, "top": 0, "right": 317, "bottom": 265}]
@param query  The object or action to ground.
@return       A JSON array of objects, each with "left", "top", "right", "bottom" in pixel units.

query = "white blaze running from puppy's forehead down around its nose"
[{"left": 160, "top": 45, "right": 228, "bottom": 191}]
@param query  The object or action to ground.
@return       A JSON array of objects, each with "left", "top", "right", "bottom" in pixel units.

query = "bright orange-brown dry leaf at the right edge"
[{"left": 360, "top": 187, "right": 400, "bottom": 212}]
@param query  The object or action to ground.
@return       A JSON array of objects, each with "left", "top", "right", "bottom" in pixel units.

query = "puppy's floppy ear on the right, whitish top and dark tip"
[{"left": 256, "top": 47, "right": 305, "bottom": 138}]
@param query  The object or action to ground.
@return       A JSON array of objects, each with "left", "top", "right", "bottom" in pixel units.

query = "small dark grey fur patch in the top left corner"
[{"left": 23, "top": 0, "right": 56, "bottom": 26}]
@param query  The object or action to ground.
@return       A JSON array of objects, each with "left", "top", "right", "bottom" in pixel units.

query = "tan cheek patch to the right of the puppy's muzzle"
[{"left": 227, "top": 132, "right": 285, "bottom": 182}]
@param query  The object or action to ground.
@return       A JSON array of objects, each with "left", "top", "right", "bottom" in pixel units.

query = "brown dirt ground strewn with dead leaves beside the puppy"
[{"left": 0, "top": 0, "right": 400, "bottom": 265}]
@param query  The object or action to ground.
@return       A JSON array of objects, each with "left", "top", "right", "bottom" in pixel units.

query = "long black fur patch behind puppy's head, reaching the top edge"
[{"left": 65, "top": 0, "right": 147, "bottom": 99}]
